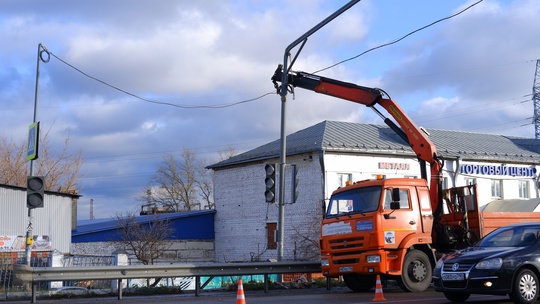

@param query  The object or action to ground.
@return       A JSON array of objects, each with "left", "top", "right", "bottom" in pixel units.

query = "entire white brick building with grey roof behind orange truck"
[{"left": 209, "top": 121, "right": 540, "bottom": 262}]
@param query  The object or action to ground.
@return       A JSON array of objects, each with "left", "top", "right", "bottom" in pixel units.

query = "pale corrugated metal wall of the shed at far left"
[{"left": 0, "top": 185, "right": 72, "bottom": 253}]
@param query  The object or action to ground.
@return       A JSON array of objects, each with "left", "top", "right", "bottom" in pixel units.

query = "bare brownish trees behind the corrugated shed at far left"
[{"left": 0, "top": 129, "right": 84, "bottom": 193}]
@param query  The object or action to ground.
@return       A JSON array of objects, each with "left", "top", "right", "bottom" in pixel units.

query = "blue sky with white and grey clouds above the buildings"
[{"left": 0, "top": 0, "right": 540, "bottom": 220}]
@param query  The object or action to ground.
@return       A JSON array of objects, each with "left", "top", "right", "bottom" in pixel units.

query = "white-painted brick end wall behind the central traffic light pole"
[{"left": 214, "top": 155, "right": 323, "bottom": 262}]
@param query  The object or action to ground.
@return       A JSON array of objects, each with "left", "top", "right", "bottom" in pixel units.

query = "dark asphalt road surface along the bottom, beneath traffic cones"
[{"left": 0, "top": 287, "right": 512, "bottom": 304}]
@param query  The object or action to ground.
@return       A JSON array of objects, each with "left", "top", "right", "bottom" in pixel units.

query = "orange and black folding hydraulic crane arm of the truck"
[{"left": 272, "top": 65, "right": 442, "bottom": 211}]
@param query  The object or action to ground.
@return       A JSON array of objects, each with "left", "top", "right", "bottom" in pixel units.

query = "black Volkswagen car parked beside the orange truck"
[{"left": 433, "top": 222, "right": 540, "bottom": 303}]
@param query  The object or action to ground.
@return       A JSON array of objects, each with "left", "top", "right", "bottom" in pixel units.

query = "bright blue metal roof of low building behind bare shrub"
[{"left": 71, "top": 210, "right": 216, "bottom": 243}]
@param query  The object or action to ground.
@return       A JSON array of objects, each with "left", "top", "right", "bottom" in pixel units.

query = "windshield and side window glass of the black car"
[{"left": 476, "top": 226, "right": 540, "bottom": 247}]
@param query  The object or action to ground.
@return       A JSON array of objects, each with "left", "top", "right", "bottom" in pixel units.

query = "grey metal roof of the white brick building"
[{"left": 208, "top": 120, "right": 540, "bottom": 169}]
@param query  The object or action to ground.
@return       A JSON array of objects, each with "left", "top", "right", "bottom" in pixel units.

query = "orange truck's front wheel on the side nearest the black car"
[{"left": 397, "top": 250, "right": 433, "bottom": 292}]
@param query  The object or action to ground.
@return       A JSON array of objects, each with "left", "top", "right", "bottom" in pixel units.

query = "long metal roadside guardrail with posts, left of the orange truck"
[{"left": 13, "top": 262, "right": 321, "bottom": 303}]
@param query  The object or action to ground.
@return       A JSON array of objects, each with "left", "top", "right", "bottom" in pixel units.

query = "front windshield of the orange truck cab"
[{"left": 326, "top": 186, "right": 382, "bottom": 217}]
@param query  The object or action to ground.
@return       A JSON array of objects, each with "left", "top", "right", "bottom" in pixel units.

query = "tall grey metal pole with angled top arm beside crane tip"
[{"left": 277, "top": 0, "right": 360, "bottom": 261}]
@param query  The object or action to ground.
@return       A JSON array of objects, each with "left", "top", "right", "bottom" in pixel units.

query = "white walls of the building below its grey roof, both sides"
[{"left": 214, "top": 153, "right": 536, "bottom": 262}]
